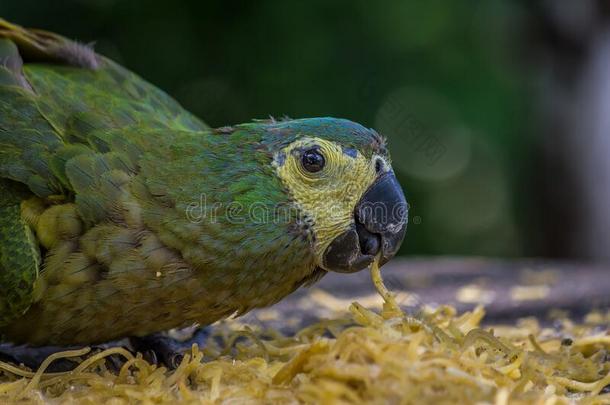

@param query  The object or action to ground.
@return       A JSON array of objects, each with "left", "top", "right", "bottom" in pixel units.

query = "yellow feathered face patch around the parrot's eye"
[{"left": 275, "top": 138, "right": 376, "bottom": 264}]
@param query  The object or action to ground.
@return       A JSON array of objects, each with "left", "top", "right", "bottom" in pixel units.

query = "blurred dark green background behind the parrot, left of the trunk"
[{"left": 0, "top": 0, "right": 604, "bottom": 257}]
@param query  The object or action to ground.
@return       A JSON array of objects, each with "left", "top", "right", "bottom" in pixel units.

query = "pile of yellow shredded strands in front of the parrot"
[{"left": 0, "top": 265, "right": 610, "bottom": 405}]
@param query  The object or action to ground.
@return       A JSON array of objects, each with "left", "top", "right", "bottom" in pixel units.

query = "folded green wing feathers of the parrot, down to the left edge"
[{"left": 0, "top": 19, "right": 208, "bottom": 327}]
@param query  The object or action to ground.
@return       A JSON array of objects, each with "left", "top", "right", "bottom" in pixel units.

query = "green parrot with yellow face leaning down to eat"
[{"left": 0, "top": 20, "right": 408, "bottom": 356}]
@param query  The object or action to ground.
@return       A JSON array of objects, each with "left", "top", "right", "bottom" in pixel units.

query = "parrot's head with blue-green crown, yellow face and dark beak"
[{"left": 254, "top": 118, "right": 408, "bottom": 273}]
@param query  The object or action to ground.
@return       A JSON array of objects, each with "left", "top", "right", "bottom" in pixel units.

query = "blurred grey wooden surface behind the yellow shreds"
[{"left": 241, "top": 258, "right": 610, "bottom": 330}]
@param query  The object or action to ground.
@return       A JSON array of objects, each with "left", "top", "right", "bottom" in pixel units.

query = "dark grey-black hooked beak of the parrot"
[{"left": 323, "top": 172, "right": 409, "bottom": 273}]
